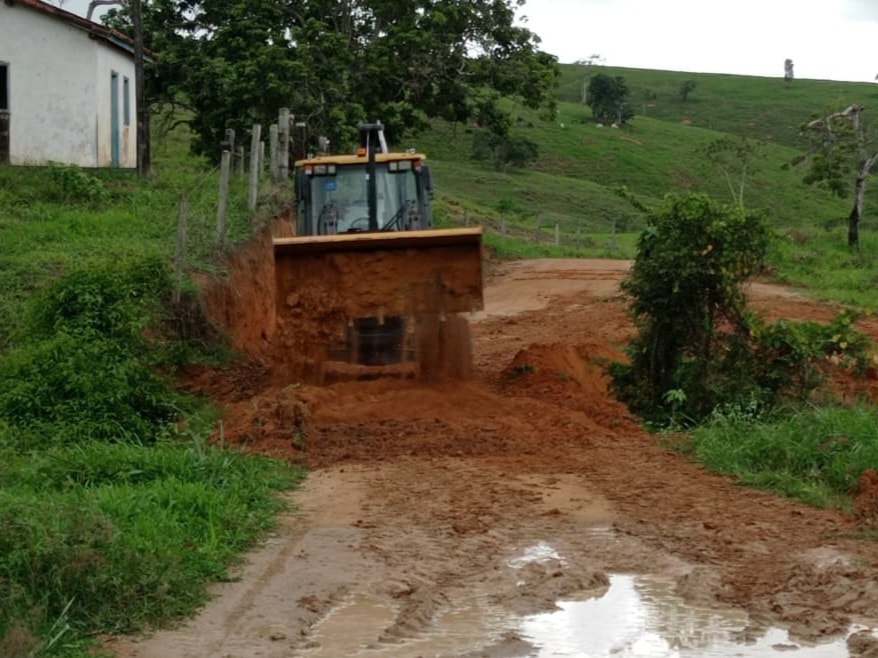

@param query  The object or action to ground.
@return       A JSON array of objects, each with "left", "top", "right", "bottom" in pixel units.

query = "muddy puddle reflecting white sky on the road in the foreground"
[{"left": 302, "top": 542, "right": 860, "bottom": 658}]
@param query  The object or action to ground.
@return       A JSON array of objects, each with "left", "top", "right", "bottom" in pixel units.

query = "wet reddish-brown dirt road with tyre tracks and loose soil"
[{"left": 110, "top": 261, "right": 878, "bottom": 658}]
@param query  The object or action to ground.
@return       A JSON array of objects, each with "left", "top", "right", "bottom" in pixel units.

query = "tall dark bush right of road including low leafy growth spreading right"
[{"left": 610, "top": 195, "right": 871, "bottom": 425}]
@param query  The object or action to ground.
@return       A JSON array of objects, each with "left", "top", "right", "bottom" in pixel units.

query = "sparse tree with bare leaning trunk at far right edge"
[{"left": 802, "top": 105, "right": 878, "bottom": 247}]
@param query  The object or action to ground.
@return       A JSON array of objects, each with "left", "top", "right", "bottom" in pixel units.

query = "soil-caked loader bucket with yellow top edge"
[{"left": 273, "top": 228, "right": 484, "bottom": 380}]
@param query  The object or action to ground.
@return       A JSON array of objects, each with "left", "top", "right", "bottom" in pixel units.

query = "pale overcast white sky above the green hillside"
[{"left": 62, "top": 0, "right": 878, "bottom": 84}]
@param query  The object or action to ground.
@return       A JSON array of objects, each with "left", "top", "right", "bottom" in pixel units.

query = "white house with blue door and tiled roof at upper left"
[{"left": 0, "top": 0, "right": 137, "bottom": 168}]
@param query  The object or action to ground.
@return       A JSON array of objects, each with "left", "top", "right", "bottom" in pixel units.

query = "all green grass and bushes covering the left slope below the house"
[{"left": 0, "top": 152, "right": 301, "bottom": 657}]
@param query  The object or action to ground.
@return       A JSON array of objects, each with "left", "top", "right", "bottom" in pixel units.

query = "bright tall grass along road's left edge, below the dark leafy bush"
[{"left": 0, "top": 441, "right": 302, "bottom": 656}]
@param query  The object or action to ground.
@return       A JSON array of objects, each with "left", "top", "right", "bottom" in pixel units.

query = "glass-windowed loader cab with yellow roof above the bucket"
[{"left": 294, "top": 153, "right": 433, "bottom": 235}]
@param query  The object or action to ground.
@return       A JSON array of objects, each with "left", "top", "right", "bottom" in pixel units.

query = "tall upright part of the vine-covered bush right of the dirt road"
[{"left": 611, "top": 194, "right": 768, "bottom": 423}]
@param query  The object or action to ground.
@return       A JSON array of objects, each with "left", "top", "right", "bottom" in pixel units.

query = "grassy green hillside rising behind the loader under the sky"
[{"left": 414, "top": 65, "right": 878, "bottom": 251}]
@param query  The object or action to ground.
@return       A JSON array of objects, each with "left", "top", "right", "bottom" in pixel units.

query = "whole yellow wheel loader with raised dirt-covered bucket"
[{"left": 273, "top": 123, "right": 483, "bottom": 379}]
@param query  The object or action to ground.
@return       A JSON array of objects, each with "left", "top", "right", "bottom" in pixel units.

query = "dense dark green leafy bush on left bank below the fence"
[{"left": 0, "top": 261, "right": 181, "bottom": 447}]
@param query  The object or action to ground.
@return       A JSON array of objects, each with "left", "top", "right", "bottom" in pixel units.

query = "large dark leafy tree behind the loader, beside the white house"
[{"left": 111, "top": 0, "right": 558, "bottom": 155}]
